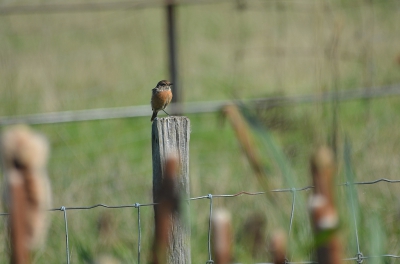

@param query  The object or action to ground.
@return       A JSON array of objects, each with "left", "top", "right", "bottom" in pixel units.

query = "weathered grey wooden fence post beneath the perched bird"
[{"left": 152, "top": 116, "right": 191, "bottom": 264}]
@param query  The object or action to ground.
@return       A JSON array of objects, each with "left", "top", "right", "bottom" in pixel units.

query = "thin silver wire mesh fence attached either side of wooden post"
[{"left": 0, "top": 178, "right": 400, "bottom": 264}]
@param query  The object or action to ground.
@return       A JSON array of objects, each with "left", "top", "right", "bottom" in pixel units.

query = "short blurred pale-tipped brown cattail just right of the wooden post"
[{"left": 211, "top": 209, "right": 233, "bottom": 264}]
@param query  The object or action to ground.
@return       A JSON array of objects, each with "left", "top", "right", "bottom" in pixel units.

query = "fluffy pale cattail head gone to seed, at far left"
[{"left": 1, "top": 125, "right": 51, "bottom": 250}]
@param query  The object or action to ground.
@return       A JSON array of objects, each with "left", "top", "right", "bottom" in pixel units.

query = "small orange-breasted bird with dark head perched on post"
[{"left": 150, "top": 80, "right": 172, "bottom": 121}]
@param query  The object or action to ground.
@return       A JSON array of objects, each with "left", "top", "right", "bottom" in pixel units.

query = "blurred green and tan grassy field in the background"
[{"left": 0, "top": 1, "right": 400, "bottom": 263}]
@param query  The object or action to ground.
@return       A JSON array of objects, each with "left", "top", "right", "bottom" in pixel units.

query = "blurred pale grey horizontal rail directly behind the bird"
[{"left": 0, "top": 84, "right": 400, "bottom": 126}]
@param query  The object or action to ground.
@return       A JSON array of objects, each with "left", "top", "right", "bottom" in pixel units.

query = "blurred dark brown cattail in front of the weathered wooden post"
[{"left": 152, "top": 157, "right": 179, "bottom": 264}]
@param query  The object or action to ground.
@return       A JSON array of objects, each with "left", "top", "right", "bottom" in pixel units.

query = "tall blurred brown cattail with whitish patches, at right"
[{"left": 310, "top": 147, "right": 342, "bottom": 264}]
